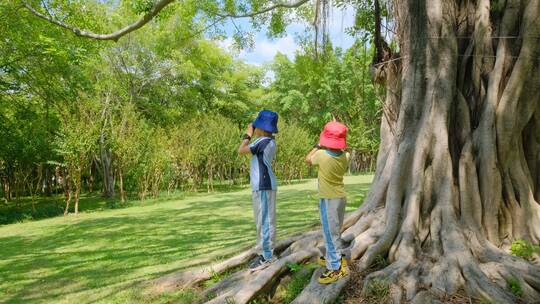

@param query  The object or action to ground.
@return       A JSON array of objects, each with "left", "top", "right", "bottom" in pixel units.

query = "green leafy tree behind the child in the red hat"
[{"left": 265, "top": 42, "right": 381, "bottom": 156}]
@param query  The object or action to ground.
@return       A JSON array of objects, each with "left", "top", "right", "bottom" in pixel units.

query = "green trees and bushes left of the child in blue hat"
[{"left": 0, "top": 0, "right": 270, "bottom": 204}]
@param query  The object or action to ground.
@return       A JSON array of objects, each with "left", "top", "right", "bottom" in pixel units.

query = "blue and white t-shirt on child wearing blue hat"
[{"left": 249, "top": 137, "right": 277, "bottom": 191}]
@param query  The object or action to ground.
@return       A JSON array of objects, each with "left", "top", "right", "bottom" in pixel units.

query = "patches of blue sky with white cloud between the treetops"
[{"left": 215, "top": 7, "right": 354, "bottom": 65}]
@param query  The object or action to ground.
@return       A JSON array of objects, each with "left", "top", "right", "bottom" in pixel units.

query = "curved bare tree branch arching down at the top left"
[{"left": 23, "top": 0, "right": 174, "bottom": 41}]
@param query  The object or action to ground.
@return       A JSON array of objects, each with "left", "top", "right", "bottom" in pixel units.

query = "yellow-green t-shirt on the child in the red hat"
[{"left": 311, "top": 150, "right": 349, "bottom": 198}]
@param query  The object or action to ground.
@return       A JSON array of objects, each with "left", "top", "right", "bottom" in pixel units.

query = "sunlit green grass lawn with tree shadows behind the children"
[{"left": 0, "top": 175, "right": 372, "bottom": 303}]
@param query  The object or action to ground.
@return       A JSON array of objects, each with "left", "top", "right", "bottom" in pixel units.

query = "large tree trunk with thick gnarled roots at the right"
[{"left": 346, "top": 0, "right": 540, "bottom": 303}]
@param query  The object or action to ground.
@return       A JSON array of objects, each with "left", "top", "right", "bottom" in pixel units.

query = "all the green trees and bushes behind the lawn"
[{"left": 0, "top": 0, "right": 379, "bottom": 216}]
